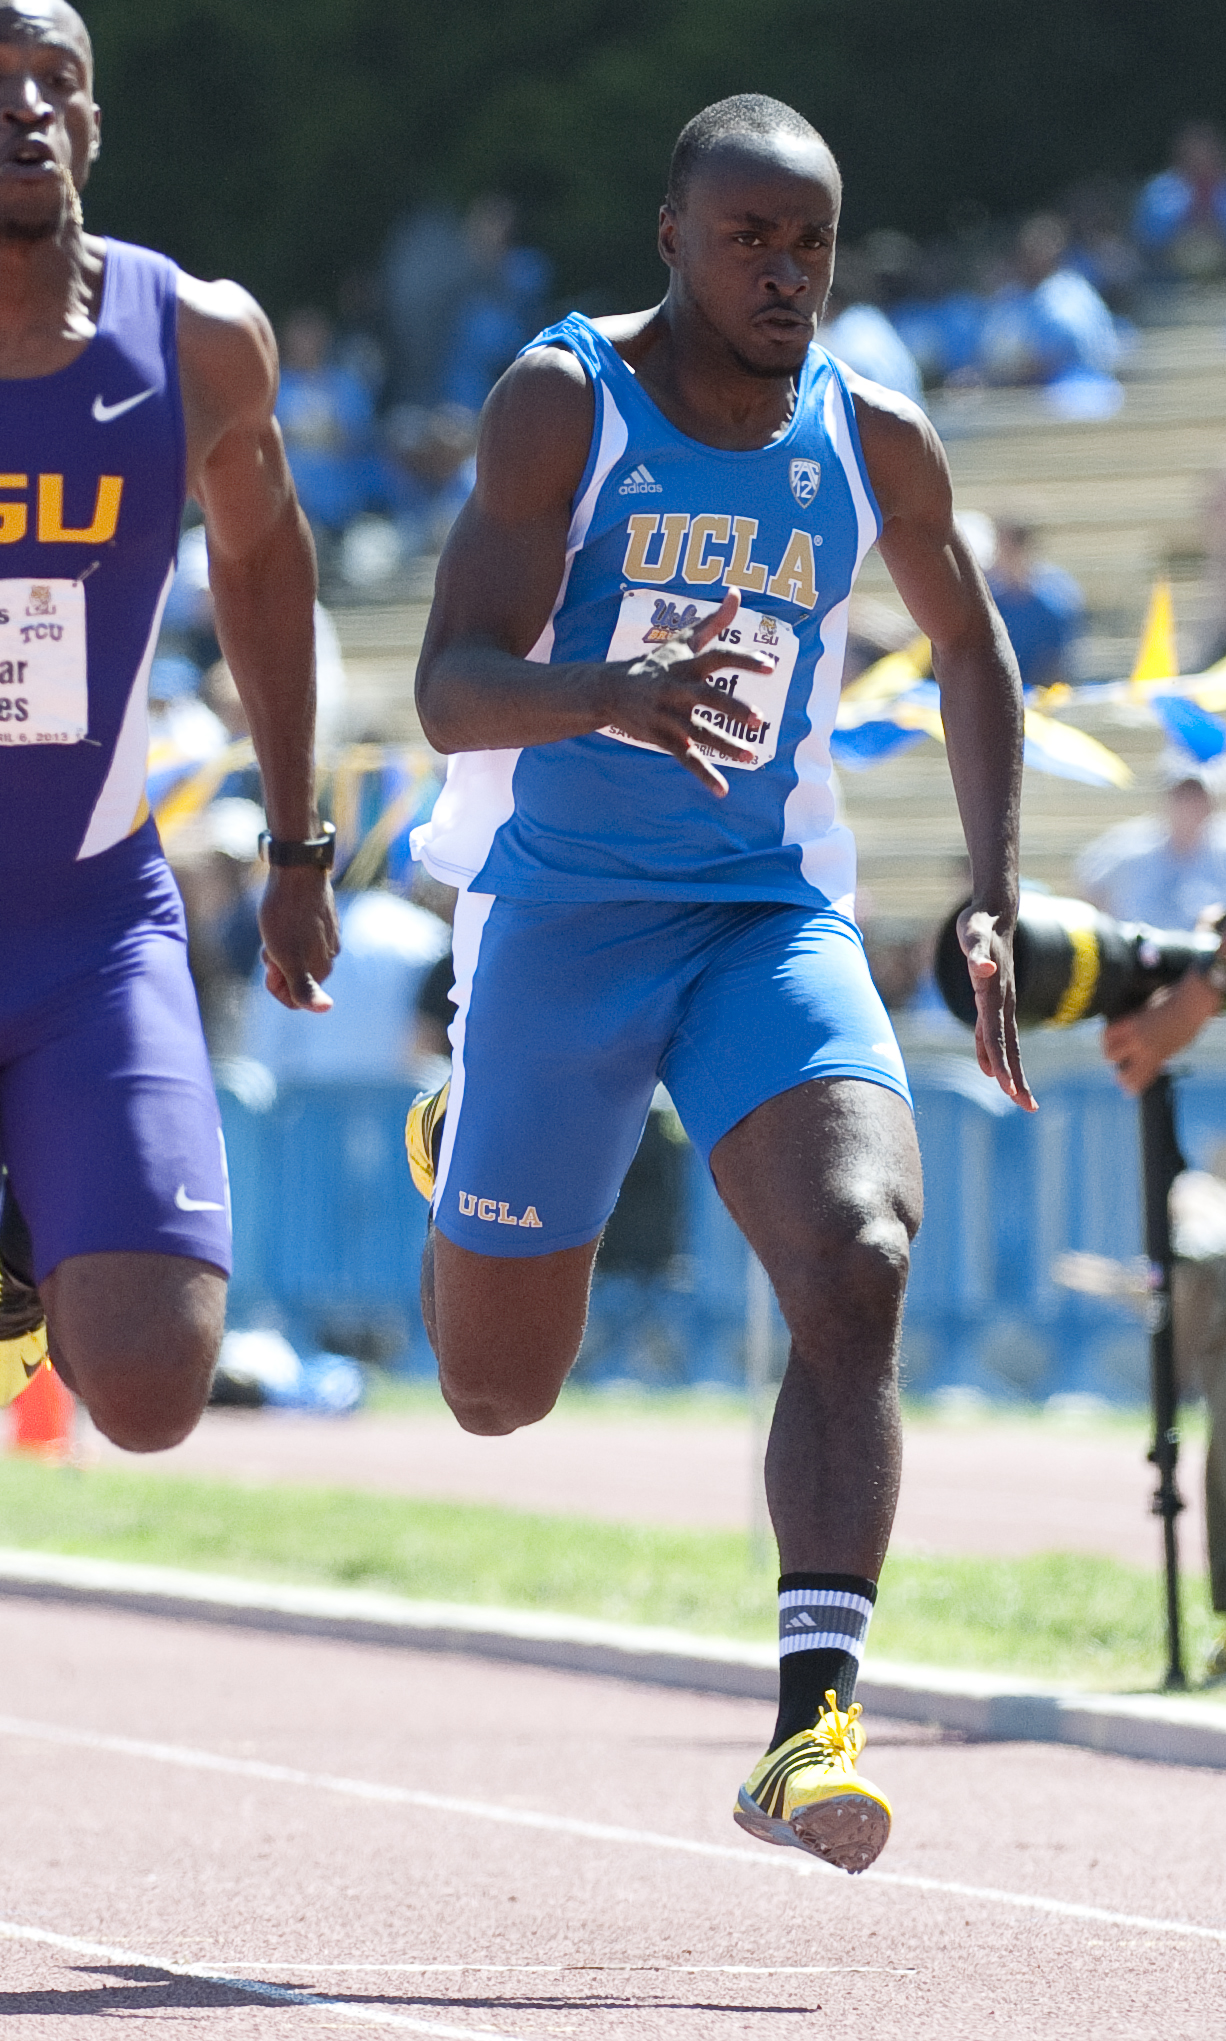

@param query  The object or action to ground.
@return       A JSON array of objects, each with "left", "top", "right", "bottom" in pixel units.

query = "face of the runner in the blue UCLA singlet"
[{"left": 659, "top": 137, "right": 842, "bottom": 376}]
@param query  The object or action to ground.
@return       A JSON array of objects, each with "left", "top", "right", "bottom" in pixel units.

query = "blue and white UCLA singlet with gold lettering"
[{"left": 414, "top": 312, "right": 881, "bottom": 912}]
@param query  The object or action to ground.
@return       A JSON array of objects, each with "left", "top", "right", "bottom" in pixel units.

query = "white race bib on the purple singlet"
[{"left": 0, "top": 582, "right": 90, "bottom": 745}]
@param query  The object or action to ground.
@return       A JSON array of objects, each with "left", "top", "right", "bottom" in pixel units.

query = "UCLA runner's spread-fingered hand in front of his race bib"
[{"left": 606, "top": 588, "right": 773, "bottom": 800}]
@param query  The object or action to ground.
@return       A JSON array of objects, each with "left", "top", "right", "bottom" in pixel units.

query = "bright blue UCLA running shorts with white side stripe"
[{"left": 435, "top": 892, "right": 910, "bottom": 1255}]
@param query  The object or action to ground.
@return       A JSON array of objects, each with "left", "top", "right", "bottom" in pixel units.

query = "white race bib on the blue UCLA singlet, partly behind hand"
[{"left": 600, "top": 588, "right": 800, "bottom": 771}]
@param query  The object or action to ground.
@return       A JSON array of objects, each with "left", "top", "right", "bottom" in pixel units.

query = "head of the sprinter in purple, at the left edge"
[{"left": 0, "top": 0, "right": 98, "bottom": 241}]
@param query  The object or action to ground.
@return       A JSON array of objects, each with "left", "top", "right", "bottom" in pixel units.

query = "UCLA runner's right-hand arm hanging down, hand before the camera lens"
[{"left": 851, "top": 378, "right": 1034, "bottom": 1110}]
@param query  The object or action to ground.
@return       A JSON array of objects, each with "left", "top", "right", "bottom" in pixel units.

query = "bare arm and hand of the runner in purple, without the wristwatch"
[{"left": 180, "top": 278, "right": 339, "bottom": 1012}]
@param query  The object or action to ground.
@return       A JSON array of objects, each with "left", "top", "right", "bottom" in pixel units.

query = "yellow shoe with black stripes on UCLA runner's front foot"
[{"left": 732, "top": 1692, "right": 889, "bottom": 1872}]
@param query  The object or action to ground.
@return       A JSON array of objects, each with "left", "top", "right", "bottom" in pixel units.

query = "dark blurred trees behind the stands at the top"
[{"left": 84, "top": 0, "right": 1226, "bottom": 312}]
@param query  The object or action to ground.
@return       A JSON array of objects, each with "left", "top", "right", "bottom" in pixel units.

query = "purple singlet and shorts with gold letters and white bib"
[{"left": 0, "top": 241, "right": 231, "bottom": 1282}]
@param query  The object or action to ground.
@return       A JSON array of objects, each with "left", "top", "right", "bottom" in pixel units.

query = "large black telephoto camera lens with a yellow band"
[{"left": 936, "top": 892, "right": 1218, "bottom": 1027}]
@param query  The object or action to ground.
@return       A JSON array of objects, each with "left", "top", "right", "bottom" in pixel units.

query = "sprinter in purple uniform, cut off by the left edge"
[{"left": 0, "top": 0, "right": 337, "bottom": 1451}]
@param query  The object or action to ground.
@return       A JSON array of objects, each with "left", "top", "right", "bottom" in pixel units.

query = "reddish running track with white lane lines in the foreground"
[{"left": 0, "top": 1600, "right": 1226, "bottom": 2041}]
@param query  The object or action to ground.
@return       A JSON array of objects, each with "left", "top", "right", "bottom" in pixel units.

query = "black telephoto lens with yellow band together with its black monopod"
[{"left": 936, "top": 892, "right": 1218, "bottom": 1688}]
